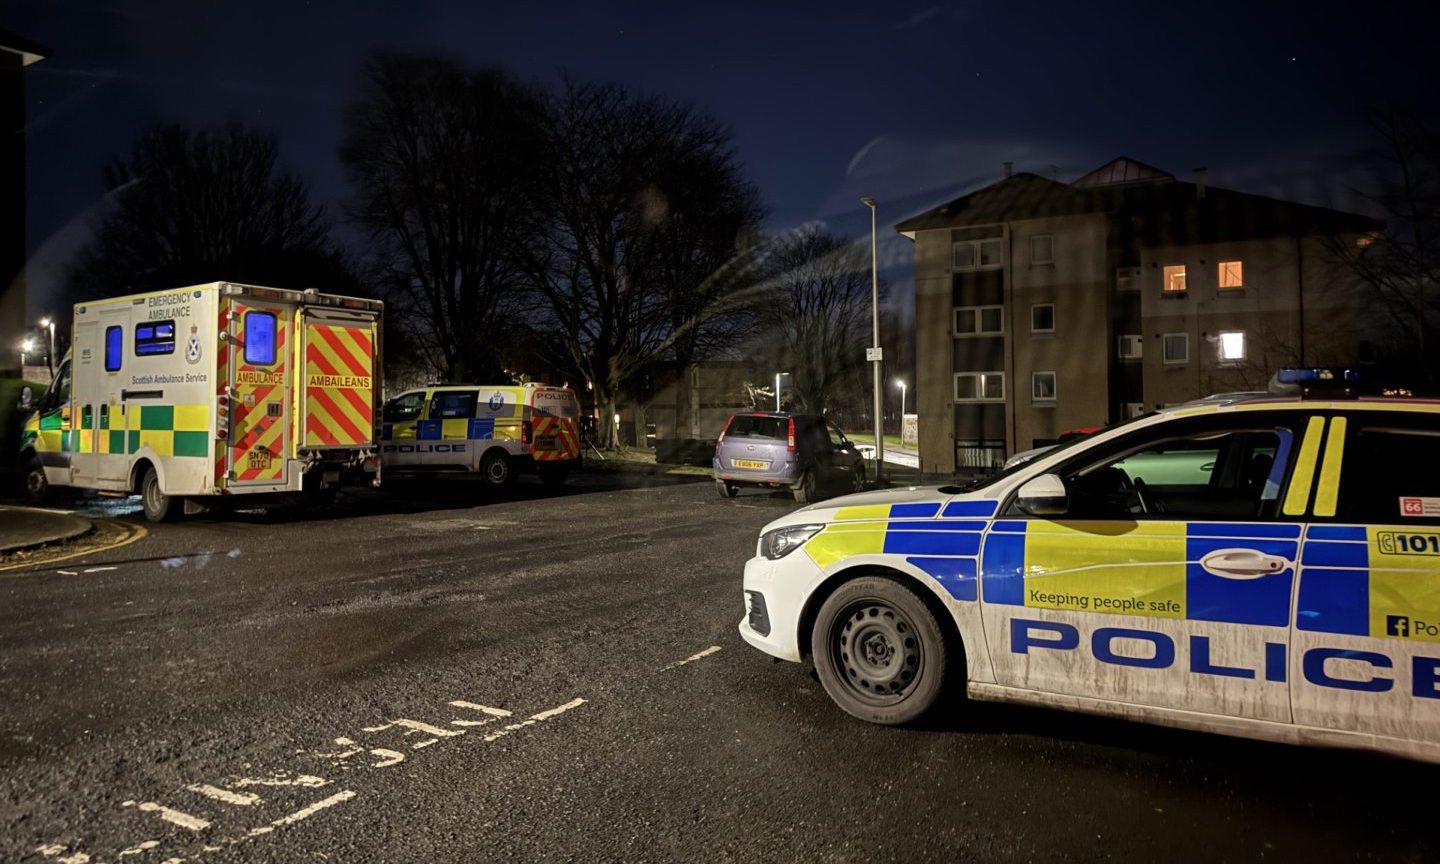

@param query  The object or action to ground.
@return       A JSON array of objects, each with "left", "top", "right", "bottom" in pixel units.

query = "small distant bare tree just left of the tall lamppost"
[{"left": 760, "top": 228, "right": 870, "bottom": 413}]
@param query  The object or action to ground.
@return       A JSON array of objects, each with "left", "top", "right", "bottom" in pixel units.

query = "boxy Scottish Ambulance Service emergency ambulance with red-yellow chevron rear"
[{"left": 22, "top": 282, "right": 383, "bottom": 521}]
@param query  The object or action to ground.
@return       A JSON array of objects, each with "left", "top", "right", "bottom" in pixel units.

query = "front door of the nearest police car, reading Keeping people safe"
[{"left": 981, "top": 412, "right": 1300, "bottom": 723}]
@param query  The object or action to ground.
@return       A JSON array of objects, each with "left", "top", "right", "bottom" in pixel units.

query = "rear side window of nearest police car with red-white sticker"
[{"left": 1335, "top": 423, "right": 1440, "bottom": 524}]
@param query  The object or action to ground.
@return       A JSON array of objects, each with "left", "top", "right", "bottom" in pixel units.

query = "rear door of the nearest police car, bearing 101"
[{"left": 1290, "top": 409, "right": 1440, "bottom": 744}]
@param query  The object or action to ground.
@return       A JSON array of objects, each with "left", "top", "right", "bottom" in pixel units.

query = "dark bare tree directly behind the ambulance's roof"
[{"left": 71, "top": 125, "right": 356, "bottom": 297}]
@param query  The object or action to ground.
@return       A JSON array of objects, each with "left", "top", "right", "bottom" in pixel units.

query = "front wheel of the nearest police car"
[{"left": 811, "top": 576, "right": 950, "bottom": 726}]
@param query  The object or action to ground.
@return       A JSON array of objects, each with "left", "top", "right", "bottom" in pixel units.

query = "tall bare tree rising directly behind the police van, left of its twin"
[{"left": 341, "top": 55, "right": 543, "bottom": 380}]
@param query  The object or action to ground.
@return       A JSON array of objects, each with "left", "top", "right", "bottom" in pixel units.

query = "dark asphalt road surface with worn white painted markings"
[{"left": 0, "top": 474, "right": 1440, "bottom": 864}]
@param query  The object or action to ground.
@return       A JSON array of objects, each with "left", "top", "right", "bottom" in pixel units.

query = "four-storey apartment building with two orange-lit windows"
[{"left": 896, "top": 157, "right": 1382, "bottom": 474}]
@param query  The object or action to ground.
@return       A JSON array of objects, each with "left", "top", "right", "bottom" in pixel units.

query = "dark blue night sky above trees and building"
[{"left": 11, "top": 0, "right": 1440, "bottom": 314}]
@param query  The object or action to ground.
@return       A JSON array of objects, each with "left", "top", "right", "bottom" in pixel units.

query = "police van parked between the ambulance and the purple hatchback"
[{"left": 380, "top": 383, "right": 580, "bottom": 487}]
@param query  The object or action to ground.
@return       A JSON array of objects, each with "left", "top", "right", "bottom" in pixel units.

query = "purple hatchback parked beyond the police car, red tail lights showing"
[{"left": 714, "top": 412, "right": 865, "bottom": 504}]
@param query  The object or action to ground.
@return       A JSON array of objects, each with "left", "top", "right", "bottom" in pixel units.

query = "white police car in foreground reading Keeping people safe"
[{"left": 740, "top": 370, "right": 1440, "bottom": 760}]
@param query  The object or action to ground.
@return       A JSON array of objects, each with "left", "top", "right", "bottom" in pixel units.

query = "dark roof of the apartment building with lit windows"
[{"left": 896, "top": 157, "right": 1385, "bottom": 245}]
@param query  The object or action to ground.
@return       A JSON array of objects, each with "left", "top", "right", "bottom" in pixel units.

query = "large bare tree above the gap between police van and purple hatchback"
[{"left": 530, "top": 82, "right": 762, "bottom": 444}]
